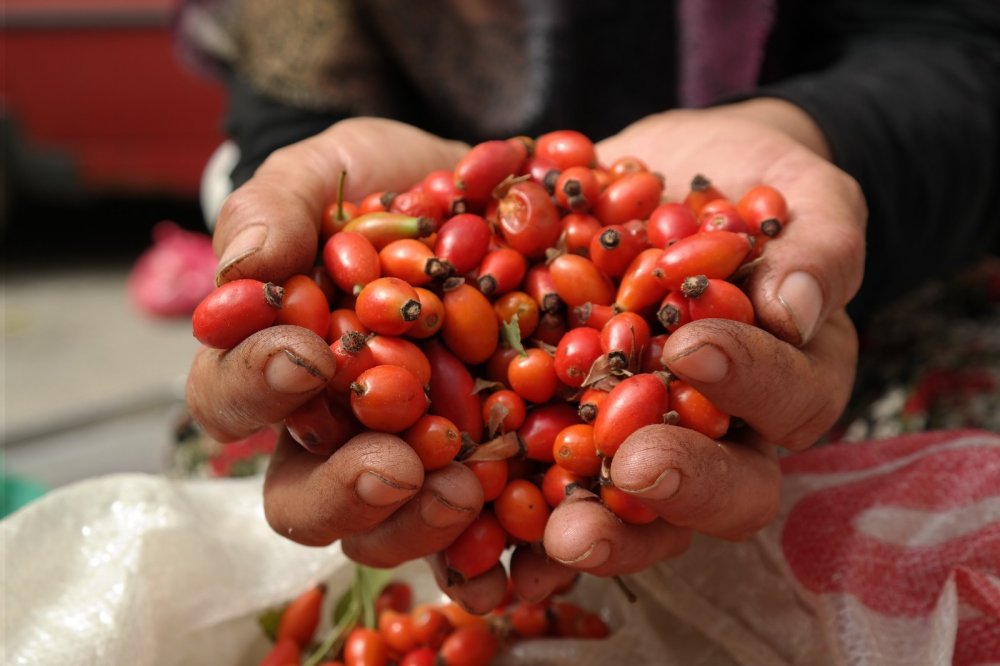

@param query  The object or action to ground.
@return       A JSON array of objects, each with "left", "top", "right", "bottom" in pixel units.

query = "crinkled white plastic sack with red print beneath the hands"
[{"left": 0, "top": 433, "right": 1000, "bottom": 666}]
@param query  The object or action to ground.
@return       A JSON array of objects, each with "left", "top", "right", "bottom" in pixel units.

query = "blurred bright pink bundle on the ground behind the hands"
[{"left": 128, "top": 220, "right": 218, "bottom": 317}]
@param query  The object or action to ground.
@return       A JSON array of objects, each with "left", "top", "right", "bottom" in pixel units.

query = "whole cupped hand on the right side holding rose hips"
[{"left": 532, "top": 100, "right": 866, "bottom": 576}]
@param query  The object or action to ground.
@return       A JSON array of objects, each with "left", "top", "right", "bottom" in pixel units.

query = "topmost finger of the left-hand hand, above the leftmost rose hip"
[{"left": 213, "top": 118, "right": 463, "bottom": 284}]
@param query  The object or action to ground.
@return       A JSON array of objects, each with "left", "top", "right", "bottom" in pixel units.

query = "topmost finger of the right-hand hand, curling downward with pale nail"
[{"left": 746, "top": 153, "right": 867, "bottom": 345}]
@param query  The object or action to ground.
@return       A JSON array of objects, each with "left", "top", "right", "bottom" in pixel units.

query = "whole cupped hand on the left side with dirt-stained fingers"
[{"left": 186, "top": 119, "right": 492, "bottom": 567}]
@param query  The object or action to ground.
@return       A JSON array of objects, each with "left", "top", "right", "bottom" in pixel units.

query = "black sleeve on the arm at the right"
[{"left": 758, "top": 0, "right": 1000, "bottom": 321}]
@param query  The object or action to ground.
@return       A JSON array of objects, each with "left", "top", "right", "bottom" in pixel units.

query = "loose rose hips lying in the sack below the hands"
[{"left": 260, "top": 580, "right": 610, "bottom": 666}]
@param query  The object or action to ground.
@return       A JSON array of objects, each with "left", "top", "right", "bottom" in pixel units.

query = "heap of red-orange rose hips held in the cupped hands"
[{"left": 193, "top": 130, "right": 788, "bottom": 581}]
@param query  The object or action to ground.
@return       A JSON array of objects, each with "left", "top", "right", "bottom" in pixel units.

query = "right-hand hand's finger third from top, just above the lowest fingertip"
[{"left": 611, "top": 425, "right": 781, "bottom": 540}]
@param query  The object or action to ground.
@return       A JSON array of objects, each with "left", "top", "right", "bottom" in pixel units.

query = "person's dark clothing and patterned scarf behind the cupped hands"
[{"left": 189, "top": 0, "right": 1000, "bottom": 322}]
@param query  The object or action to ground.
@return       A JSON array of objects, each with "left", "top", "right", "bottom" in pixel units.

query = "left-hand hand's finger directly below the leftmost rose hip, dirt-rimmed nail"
[{"left": 184, "top": 326, "right": 337, "bottom": 442}]
